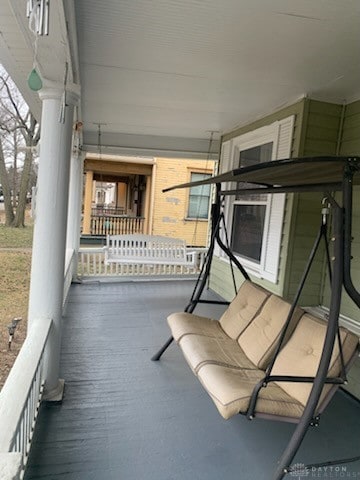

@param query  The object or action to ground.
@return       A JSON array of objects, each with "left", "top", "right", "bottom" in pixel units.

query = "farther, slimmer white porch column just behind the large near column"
[{"left": 66, "top": 149, "right": 84, "bottom": 278}]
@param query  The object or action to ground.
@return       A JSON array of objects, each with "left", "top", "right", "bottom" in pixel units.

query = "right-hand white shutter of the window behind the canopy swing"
[{"left": 261, "top": 116, "right": 294, "bottom": 283}]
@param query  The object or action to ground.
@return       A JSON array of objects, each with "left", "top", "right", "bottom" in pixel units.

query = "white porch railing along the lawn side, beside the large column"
[{"left": 0, "top": 249, "right": 76, "bottom": 480}]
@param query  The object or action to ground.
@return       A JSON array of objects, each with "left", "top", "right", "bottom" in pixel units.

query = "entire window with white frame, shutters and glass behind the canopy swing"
[{"left": 217, "top": 116, "right": 294, "bottom": 283}]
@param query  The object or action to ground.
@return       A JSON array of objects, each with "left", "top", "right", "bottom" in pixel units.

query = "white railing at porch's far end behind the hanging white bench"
[{"left": 78, "top": 247, "right": 207, "bottom": 277}]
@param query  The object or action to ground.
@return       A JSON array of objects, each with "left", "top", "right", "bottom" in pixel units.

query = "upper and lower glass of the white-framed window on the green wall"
[{"left": 231, "top": 142, "right": 273, "bottom": 263}]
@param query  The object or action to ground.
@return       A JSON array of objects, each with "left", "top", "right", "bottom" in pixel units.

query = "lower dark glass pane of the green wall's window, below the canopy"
[{"left": 231, "top": 205, "right": 266, "bottom": 263}]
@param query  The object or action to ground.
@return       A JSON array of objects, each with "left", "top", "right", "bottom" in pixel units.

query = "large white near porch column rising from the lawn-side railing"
[{"left": 28, "top": 82, "right": 78, "bottom": 400}]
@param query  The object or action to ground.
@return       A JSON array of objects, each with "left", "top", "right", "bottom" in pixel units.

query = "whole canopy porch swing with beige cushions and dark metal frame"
[{"left": 152, "top": 157, "right": 360, "bottom": 480}]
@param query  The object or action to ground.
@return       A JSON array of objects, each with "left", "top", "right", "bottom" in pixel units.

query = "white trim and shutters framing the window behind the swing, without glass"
[{"left": 215, "top": 115, "right": 295, "bottom": 283}]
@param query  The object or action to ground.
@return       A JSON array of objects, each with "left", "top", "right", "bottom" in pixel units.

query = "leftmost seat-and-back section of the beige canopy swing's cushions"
[{"left": 167, "top": 280, "right": 270, "bottom": 342}]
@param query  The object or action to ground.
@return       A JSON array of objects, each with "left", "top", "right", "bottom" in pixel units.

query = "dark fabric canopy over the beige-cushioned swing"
[{"left": 163, "top": 157, "right": 360, "bottom": 195}]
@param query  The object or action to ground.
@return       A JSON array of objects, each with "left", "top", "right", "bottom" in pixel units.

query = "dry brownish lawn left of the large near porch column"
[{"left": 0, "top": 219, "right": 33, "bottom": 388}]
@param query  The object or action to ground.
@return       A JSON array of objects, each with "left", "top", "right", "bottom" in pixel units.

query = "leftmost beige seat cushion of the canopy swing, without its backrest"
[{"left": 167, "top": 312, "right": 227, "bottom": 342}]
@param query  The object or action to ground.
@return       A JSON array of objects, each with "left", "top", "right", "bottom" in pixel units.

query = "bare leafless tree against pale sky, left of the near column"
[{"left": 0, "top": 67, "right": 40, "bottom": 227}]
